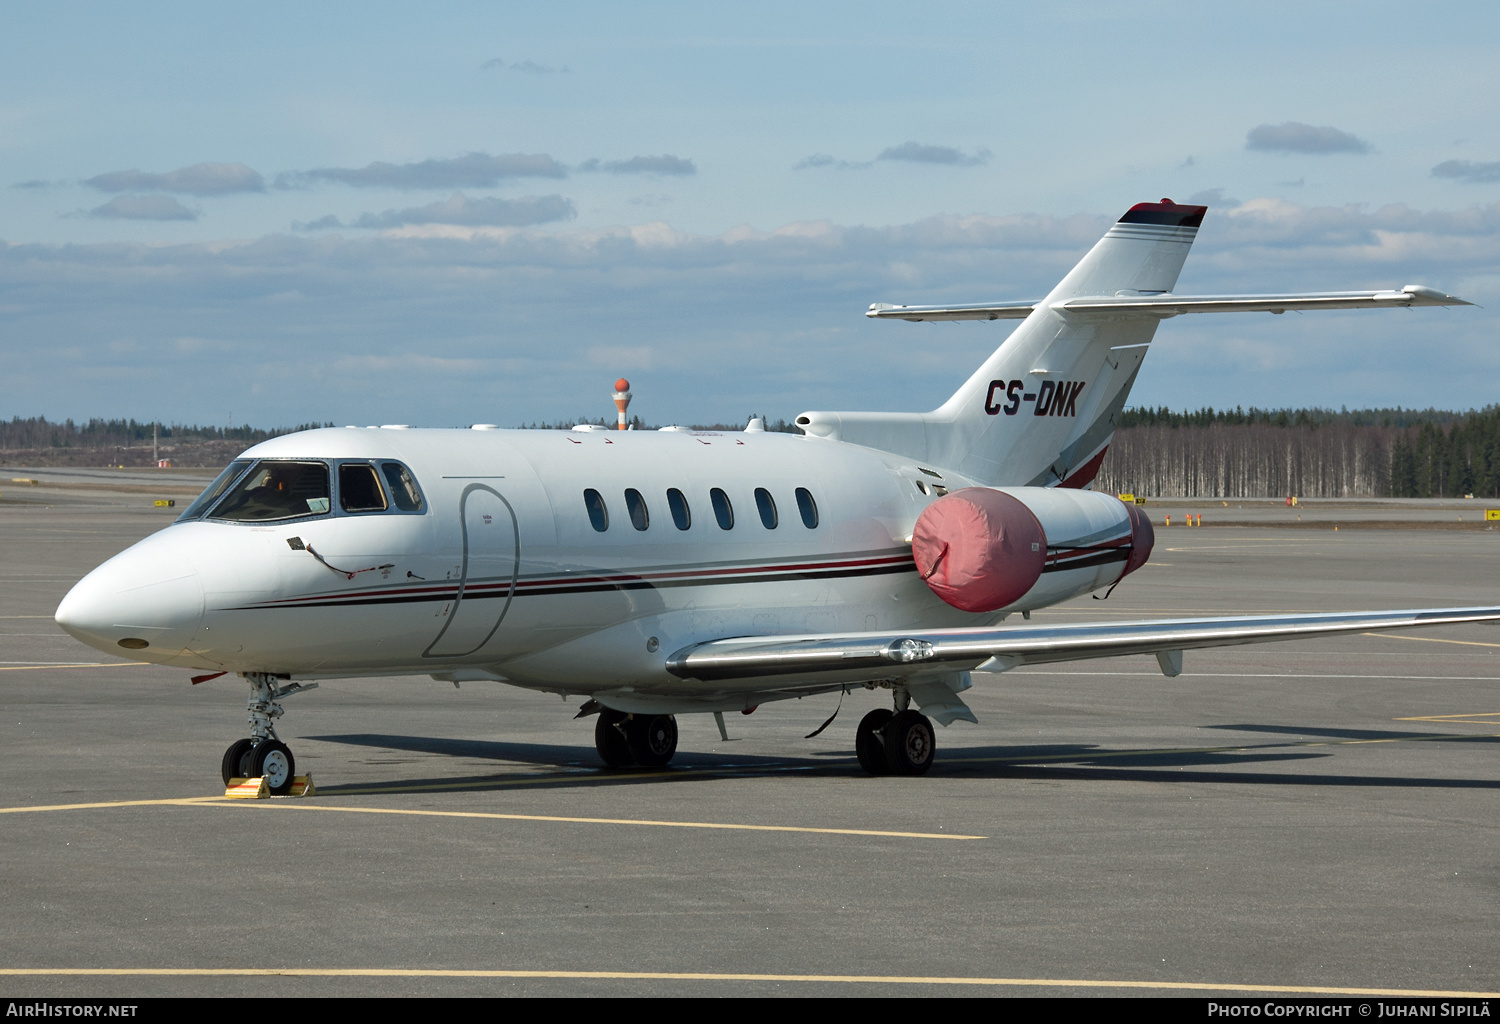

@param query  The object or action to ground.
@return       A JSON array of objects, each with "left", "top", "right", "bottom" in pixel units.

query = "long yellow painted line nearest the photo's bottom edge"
[{"left": 0, "top": 967, "right": 1500, "bottom": 999}]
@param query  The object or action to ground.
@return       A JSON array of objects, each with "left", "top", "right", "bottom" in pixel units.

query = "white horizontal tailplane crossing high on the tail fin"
[{"left": 866, "top": 285, "right": 1473, "bottom": 321}]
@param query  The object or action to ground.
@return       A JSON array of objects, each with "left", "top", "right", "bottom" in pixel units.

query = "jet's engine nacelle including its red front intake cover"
[{"left": 912, "top": 487, "right": 1155, "bottom": 612}]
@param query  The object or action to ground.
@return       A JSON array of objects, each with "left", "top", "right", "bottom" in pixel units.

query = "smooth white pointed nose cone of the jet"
[{"left": 54, "top": 538, "right": 203, "bottom": 661}]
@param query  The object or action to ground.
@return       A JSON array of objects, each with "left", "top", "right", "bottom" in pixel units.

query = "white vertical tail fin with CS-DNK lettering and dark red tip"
[{"left": 797, "top": 199, "right": 1208, "bottom": 487}]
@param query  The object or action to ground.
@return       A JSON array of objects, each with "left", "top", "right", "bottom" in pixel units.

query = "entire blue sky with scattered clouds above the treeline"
[{"left": 0, "top": 3, "right": 1500, "bottom": 426}]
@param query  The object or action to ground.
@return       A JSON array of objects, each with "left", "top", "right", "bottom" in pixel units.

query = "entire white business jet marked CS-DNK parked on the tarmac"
[{"left": 57, "top": 199, "right": 1500, "bottom": 792}]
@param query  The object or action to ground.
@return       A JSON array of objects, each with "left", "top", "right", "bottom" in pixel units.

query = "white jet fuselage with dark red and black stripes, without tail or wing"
[{"left": 59, "top": 429, "right": 1124, "bottom": 704}]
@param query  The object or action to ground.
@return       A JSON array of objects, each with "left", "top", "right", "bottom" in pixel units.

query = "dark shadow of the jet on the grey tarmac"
[{"left": 306, "top": 724, "right": 1500, "bottom": 796}]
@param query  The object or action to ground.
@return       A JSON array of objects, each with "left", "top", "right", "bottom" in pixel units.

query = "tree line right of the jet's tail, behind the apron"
[{"left": 1095, "top": 406, "right": 1500, "bottom": 498}]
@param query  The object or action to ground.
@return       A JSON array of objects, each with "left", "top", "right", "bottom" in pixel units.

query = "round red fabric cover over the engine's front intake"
[{"left": 912, "top": 487, "right": 1044, "bottom": 612}]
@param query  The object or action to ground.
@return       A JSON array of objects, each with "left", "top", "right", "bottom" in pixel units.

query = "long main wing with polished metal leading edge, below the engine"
[{"left": 666, "top": 607, "right": 1500, "bottom": 682}]
